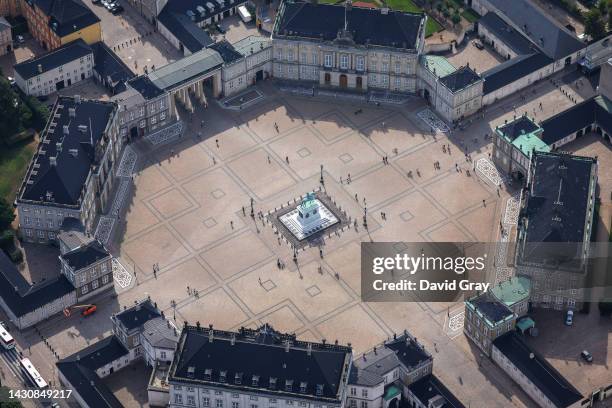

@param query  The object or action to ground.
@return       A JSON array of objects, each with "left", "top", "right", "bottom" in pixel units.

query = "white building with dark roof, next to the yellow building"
[{"left": 15, "top": 39, "right": 94, "bottom": 96}]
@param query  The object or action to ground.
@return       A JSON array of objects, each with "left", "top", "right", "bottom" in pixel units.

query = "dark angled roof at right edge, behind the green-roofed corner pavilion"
[{"left": 542, "top": 95, "right": 612, "bottom": 145}]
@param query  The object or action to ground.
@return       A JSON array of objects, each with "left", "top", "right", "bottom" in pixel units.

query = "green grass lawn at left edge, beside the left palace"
[{"left": 0, "top": 141, "right": 36, "bottom": 203}]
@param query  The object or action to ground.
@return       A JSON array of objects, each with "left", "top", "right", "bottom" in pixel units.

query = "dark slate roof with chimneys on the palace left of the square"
[{"left": 18, "top": 96, "right": 115, "bottom": 206}]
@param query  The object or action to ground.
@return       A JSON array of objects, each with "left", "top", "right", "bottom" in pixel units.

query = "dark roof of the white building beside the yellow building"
[{"left": 14, "top": 38, "right": 93, "bottom": 81}]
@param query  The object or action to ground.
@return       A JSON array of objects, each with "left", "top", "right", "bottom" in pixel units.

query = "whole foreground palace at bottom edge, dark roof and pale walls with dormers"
[{"left": 168, "top": 325, "right": 352, "bottom": 408}]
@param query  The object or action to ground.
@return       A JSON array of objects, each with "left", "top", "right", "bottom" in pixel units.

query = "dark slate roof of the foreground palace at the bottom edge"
[{"left": 168, "top": 325, "right": 351, "bottom": 403}]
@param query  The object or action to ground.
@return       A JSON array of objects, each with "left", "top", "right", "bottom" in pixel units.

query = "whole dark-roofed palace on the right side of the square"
[{"left": 515, "top": 152, "right": 597, "bottom": 310}]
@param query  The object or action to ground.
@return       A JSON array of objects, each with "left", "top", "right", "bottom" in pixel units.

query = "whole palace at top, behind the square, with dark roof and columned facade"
[{"left": 272, "top": 2, "right": 426, "bottom": 93}]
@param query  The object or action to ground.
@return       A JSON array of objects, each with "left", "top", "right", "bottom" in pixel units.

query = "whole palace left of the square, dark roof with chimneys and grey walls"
[{"left": 16, "top": 96, "right": 125, "bottom": 243}]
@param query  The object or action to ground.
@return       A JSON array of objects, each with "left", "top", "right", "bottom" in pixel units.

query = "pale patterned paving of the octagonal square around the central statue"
[{"left": 31, "top": 84, "right": 548, "bottom": 407}]
